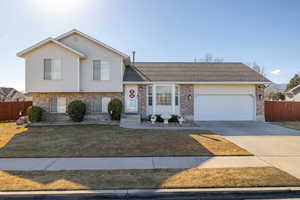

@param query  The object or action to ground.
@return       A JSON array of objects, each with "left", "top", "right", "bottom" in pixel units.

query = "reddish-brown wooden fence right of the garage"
[{"left": 265, "top": 101, "right": 300, "bottom": 121}]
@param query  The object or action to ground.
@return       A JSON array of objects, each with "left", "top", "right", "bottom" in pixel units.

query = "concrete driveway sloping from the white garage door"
[{"left": 197, "top": 121, "right": 300, "bottom": 178}]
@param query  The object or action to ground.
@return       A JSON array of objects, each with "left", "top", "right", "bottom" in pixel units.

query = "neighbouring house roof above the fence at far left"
[{"left": 0, "top": 87, "right": 30, "bottom": 102}]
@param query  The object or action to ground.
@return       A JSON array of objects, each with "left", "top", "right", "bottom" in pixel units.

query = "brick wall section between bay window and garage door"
[{"left": 179, "top": 85, "right": 194, "bottom": 120}]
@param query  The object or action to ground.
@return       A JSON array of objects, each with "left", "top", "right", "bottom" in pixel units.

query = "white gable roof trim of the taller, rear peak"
[{"left": 55, "top": 29, "right": 129, "bottom": 58}]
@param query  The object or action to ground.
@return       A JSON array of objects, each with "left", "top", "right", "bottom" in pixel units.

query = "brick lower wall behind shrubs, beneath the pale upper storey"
[{"left": 32, "top": 92, "right": 122, "bottom": 121}]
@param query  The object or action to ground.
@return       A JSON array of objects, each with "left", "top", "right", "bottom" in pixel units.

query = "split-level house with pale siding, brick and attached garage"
[{"left": 17, "top": 30, "right": 270, "bottom": 120}]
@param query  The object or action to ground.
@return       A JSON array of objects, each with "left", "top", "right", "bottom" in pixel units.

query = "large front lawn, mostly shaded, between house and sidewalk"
[{"left": 0, "top": 123, "right": 251, "bottom": 157}]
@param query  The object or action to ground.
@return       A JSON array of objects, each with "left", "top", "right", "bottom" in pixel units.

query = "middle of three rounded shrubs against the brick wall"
[{"left": 68, "top": 100, "right": 86, "bottom": 122}]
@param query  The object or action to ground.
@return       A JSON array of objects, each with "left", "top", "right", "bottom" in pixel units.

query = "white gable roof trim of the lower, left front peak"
[{"left": 17, "top": 38, "right": 86, "bottom": 58}]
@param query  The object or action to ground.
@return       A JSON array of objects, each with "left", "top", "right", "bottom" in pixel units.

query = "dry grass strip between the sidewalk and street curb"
[{"left": 0, "top": 167, "right": 300, "bottom": 191}]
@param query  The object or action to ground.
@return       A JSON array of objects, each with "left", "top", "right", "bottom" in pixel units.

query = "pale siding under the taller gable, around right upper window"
[{"left": 60, "top": 34, "right": 123, "bottom": 92}]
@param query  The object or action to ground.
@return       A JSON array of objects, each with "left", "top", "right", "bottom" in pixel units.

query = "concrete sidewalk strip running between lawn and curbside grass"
[{"left": 0, "top": 156, "right": 271, "bottom": 171}]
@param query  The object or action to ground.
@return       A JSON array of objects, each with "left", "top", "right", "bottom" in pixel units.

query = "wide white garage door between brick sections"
[{"left": 195, "top": 95, "right": 254, "bottom": 120}]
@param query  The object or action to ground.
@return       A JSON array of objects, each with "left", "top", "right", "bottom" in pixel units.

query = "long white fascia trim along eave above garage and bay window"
[{"left": 123, "top": 81, "right": 271, "bottom": 85}]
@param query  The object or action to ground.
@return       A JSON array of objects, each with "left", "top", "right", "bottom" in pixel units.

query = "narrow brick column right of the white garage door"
[{"left": 255, "top": 85, "right": 265, "bottom": 121}]
